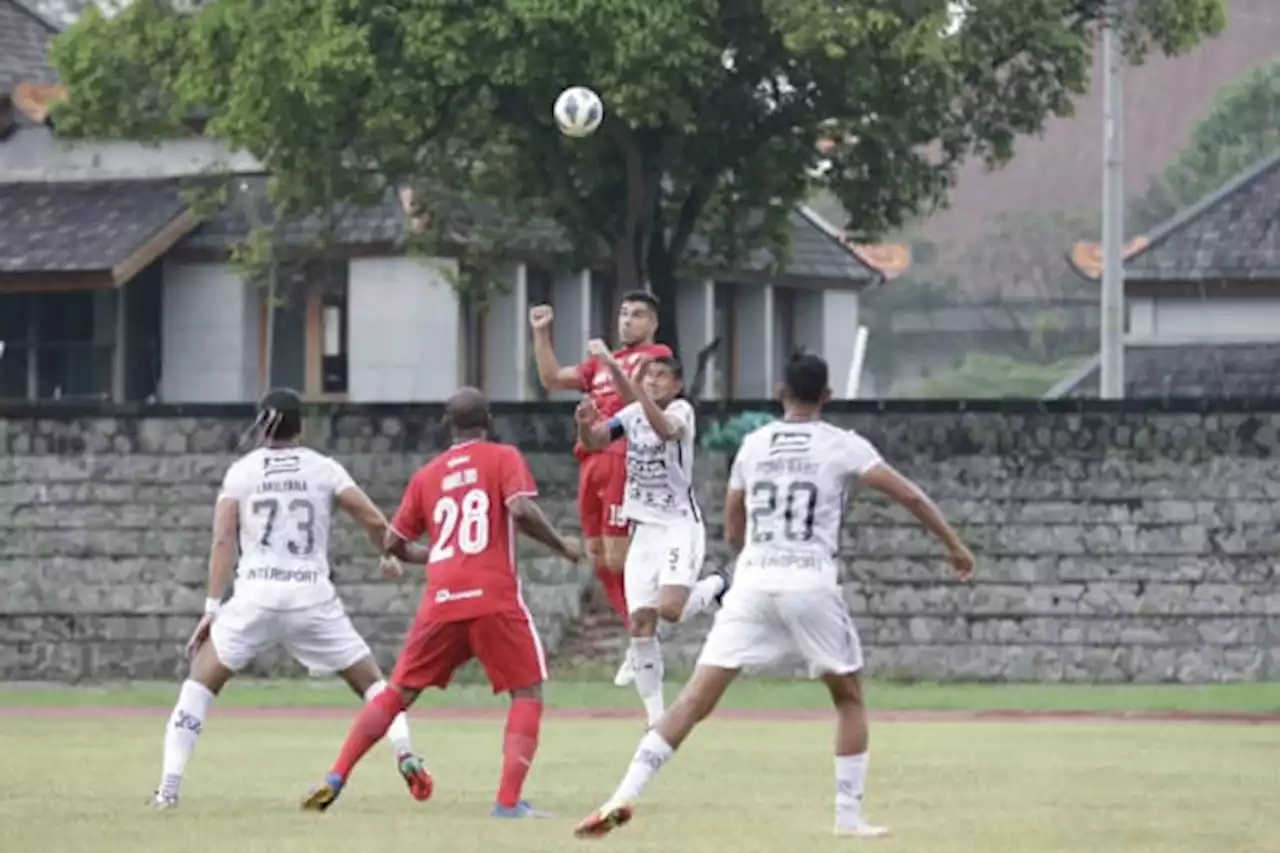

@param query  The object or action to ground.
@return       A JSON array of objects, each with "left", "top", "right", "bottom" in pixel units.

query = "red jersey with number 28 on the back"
[{"left": 392, "top": 439, "right": 538, "bottom": 622}]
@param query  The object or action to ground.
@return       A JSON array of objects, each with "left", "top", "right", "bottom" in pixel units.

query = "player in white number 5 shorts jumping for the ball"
[{"left": 576, "top": 341, "right": 728, "bottom": 726}]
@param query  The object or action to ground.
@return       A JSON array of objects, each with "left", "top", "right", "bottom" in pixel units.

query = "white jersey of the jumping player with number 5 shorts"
[{"left": 609, "top": 398, "right": 703, "bottom": 524}]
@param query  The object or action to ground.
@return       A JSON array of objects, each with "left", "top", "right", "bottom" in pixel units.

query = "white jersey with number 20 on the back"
[{"left": 728, "top": 420, "right": 881, "bottom": 592}]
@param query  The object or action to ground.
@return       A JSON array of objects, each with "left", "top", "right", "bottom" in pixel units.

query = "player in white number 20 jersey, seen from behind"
[{"left": 575, "top": 353, "right": 974, "bottom": 839}]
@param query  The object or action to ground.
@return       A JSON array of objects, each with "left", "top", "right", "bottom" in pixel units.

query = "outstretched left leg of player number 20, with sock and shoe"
[{"left": 573, "top": 666, "right": 739, "bottom": 838}]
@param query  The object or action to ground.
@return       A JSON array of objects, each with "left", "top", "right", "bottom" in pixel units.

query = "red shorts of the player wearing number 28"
[{"left": 390, "top": 611, "right": 547, "bottom": 693}]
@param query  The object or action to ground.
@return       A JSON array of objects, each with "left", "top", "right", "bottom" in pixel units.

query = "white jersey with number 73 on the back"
[{"left": 218, "top": 447, "right": 356, "bottom": 610}]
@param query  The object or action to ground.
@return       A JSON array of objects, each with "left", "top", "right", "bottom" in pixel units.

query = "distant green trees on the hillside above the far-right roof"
[{"left": 1132, "top": 61, "right": 1280, "bottom": 232}]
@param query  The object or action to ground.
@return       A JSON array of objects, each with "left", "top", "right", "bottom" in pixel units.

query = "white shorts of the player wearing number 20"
[{"left": 698, "top": 587, "right": 863, "bottom": 678}]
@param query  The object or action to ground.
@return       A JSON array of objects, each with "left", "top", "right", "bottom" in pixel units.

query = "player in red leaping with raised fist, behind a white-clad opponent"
[{"left": 529, "top": 291, "right": 673, "bottom": 686}]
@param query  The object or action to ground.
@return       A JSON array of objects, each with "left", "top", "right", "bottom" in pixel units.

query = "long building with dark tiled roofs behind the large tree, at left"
[{"left": 0, "top": 0, "right": 909, "bottom": 402}]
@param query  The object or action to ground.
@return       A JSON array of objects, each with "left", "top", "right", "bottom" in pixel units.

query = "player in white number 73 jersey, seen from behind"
[{"left": 151, "top": 389, "right": 431, "bottom": 808}]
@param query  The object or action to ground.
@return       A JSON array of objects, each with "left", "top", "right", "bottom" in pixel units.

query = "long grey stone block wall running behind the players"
[{"left": 0, "top": 403, "right": 1280, "bottom": 681}]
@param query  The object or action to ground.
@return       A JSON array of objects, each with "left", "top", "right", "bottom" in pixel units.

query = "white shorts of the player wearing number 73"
[{"left": 210, "top": 596, "right": 371, "bottom": 675}]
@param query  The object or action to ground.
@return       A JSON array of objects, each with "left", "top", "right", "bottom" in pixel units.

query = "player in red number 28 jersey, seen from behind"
[{"left": 302, "top": 388, "right": 581, "bottom": 817}]
